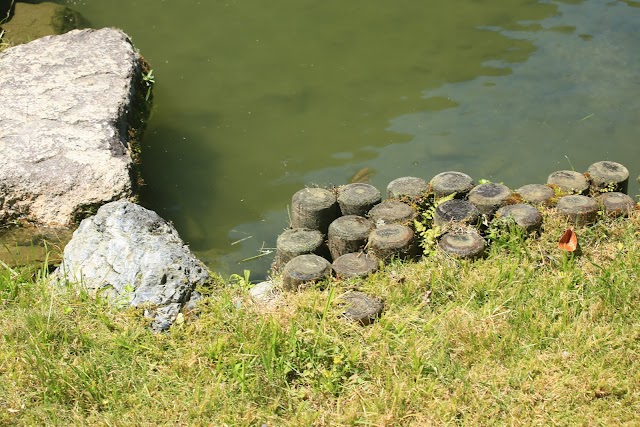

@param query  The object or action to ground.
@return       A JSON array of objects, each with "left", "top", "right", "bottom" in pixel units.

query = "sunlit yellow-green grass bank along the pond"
[{"left": 0, "top": 207, "right": 640, "bottom": 427}]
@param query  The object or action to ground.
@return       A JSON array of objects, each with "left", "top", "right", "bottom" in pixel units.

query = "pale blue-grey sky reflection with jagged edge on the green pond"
[{"left": 378, "top": 2, "right": 640, "bottom": 191}]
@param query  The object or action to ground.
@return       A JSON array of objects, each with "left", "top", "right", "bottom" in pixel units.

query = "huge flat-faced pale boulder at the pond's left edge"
[{"left": 0, "top": 28, "right": 147, "bottom": 226}]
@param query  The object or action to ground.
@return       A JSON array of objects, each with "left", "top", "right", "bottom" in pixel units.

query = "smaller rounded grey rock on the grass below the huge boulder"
[{"left": 53, "top": 200, "right": 211, "bottom": 330}]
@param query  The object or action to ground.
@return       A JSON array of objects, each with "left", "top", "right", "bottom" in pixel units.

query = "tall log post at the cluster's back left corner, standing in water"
[{"left": 291, "top": 188, "right": 338, "bottom": 234}]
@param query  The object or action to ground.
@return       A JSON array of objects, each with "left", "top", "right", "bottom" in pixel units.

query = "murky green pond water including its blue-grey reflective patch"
[{"left": 51, "top": 0, "right": 640, "bottom": 278}]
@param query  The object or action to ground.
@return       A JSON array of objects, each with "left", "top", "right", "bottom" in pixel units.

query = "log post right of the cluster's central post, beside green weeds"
[{"left": 369, "top": 224, "right": 417, "bottom": 261}]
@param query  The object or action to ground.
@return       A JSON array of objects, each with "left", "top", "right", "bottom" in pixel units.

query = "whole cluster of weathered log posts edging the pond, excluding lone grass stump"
[{"left": 274, "top": 161, "right": 635, "bottom": 289}]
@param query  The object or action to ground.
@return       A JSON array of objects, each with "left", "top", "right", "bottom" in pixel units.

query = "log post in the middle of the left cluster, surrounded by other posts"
[{"left": 329, "top": 215, "right": 374, "bottom": 260}]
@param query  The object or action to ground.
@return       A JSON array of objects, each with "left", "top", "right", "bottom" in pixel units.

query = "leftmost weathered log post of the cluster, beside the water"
[{"left": 274, "top": 228, "right": 326, "bottom": 270}]
